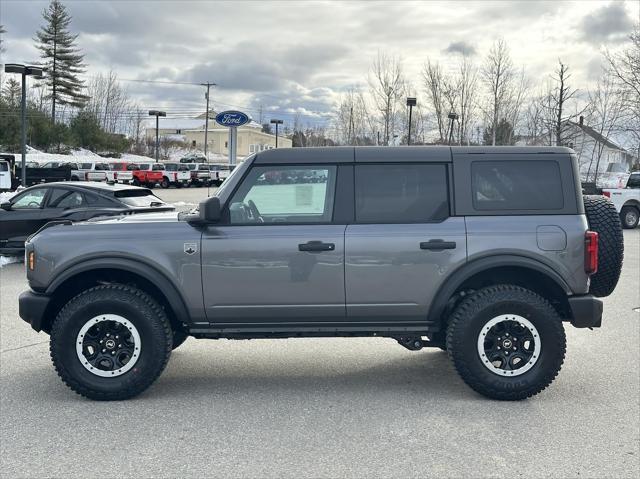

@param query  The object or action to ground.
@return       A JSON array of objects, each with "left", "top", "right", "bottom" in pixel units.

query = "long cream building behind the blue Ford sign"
[{"left": 145, "top": 112, "right": 292, "bottom": 157}]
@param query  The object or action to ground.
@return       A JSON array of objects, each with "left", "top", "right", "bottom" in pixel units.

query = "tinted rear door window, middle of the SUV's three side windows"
[{"left": 356, "top": 164, "right": 449, "bottom": 223}]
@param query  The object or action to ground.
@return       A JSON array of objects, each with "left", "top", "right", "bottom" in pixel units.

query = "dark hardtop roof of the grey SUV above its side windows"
[{"left": 255, "top": 146, "right": 573, "bottom": 164}]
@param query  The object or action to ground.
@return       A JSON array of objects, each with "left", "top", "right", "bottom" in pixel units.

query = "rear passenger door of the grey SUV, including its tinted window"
[{"left": 345, "top": 161, "right": 466, "bottom": 324}]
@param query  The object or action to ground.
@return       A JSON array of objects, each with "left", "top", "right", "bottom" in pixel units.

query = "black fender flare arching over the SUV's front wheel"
[{"left": 45, "top": 256, "right": 190, "bottom": 323}]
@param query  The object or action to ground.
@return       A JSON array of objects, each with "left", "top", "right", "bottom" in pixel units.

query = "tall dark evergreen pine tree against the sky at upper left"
[{"left": 34, "top": 0, "right": 87, "bottom": 122}]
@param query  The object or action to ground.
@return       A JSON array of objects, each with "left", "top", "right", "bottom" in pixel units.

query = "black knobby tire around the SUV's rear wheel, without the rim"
[{"left": 447, "top": 285, "right": 566, "bottom": 401}]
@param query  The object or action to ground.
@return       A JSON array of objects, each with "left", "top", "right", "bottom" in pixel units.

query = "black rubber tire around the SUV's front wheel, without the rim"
[{"left": 51, "top": 297, "right": 167, "bottom": 394}]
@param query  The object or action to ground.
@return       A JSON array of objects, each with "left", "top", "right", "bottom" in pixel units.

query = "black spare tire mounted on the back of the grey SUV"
[{"left": 583, "top": 195, "right": 624, "bottom": 298}]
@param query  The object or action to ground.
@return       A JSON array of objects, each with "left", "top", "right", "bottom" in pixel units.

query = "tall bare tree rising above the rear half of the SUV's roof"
[{"left": 480, "top": 38, "right": 515, "bottom": 145}]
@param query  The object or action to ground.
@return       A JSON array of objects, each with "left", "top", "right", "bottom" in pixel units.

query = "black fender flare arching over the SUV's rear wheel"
[{"left": 427, "top": 255, "right": 573, "bottom": 323}]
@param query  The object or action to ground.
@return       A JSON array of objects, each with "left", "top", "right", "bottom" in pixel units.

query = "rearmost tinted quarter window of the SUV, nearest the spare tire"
[{"left": 471, "top": 160, "right": 564, "bottom": 210}]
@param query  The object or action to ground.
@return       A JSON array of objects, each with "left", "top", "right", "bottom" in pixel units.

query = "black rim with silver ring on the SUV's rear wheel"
[{"left": 477, "top": 314, "right": 541, "bottom": 376}]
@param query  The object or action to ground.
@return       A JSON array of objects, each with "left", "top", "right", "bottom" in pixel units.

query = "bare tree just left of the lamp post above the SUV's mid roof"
[{"left": 369, "top": 52, "right": 404, "bottom": 145}]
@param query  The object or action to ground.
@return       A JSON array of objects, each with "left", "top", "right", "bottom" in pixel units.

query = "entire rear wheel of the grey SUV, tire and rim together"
[{"left": 447, "top": 285, "right": 566, "bottom": 401}]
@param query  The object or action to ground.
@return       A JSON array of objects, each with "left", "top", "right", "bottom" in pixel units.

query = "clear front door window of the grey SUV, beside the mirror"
[{"left": 229, "top": 165, "right": 336, "bottom": 224}]
